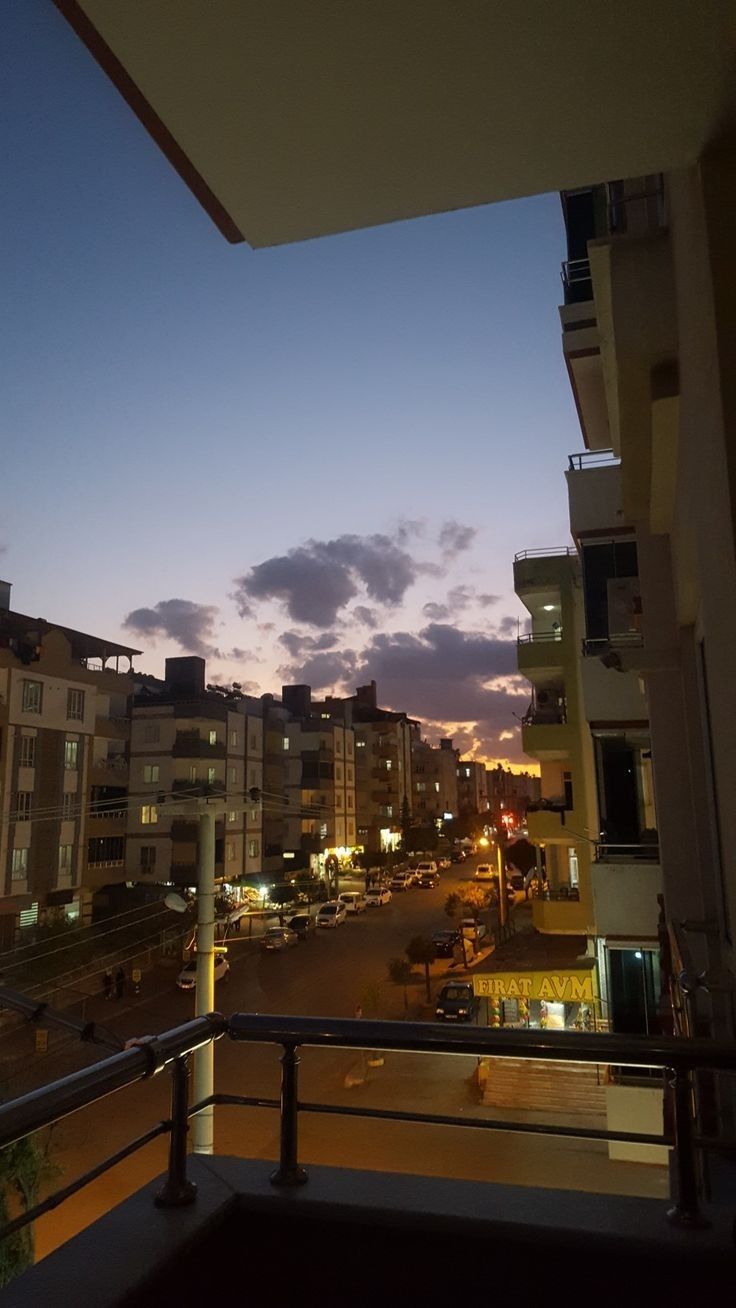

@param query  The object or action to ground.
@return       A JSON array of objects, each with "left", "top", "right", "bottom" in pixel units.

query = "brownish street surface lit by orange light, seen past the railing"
[{"left": 10, "top": 865, "right": 667, "bottom": 1256}]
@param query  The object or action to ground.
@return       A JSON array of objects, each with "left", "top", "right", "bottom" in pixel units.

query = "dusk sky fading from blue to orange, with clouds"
[{"left": 0, "top": 0, "right": 580, "bottom": 764}]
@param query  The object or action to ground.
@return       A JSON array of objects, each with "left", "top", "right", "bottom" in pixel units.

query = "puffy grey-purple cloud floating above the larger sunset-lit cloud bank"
[{"left": 234, "top": 535, "right": 420, "bottom": 627}]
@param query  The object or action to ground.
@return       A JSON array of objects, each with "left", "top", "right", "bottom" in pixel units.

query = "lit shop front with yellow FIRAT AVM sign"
[{"left": 473, "top": 959, "right": 600, "bottom": 1031}]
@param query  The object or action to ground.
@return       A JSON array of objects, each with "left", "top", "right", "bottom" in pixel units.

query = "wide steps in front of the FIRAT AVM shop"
[{"left": 482, "top": 1058, "right": 608, "bottom": 1113}]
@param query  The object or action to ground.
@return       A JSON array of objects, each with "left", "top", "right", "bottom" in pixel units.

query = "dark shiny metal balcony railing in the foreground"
[{"left": 0, "top": 990, "right": 736, "bottom": 1240}]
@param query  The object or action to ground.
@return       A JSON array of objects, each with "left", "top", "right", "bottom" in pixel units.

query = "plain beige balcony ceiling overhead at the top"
[{"left": 55, "top": 0, "right": 736, "bottom": 247}]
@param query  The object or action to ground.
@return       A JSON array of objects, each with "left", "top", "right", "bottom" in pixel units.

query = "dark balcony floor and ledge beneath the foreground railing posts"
[{"left": 7, "top": 1158, "right": 733, "bottom": 1308}]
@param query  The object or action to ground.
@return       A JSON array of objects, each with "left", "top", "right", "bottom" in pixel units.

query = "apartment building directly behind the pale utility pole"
[{"left": 125, "top": 657, "right": 264, "bottom": 886}]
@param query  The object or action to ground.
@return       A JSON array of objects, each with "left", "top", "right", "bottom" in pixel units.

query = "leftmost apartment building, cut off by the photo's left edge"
[{"left": 0, "top": 582, "right": 139, "bottom": 947}]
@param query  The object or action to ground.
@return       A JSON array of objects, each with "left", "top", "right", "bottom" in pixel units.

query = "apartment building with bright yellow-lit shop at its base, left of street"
[{"left": 281, "top": 685, "right": 357, "bottom": 869}]
